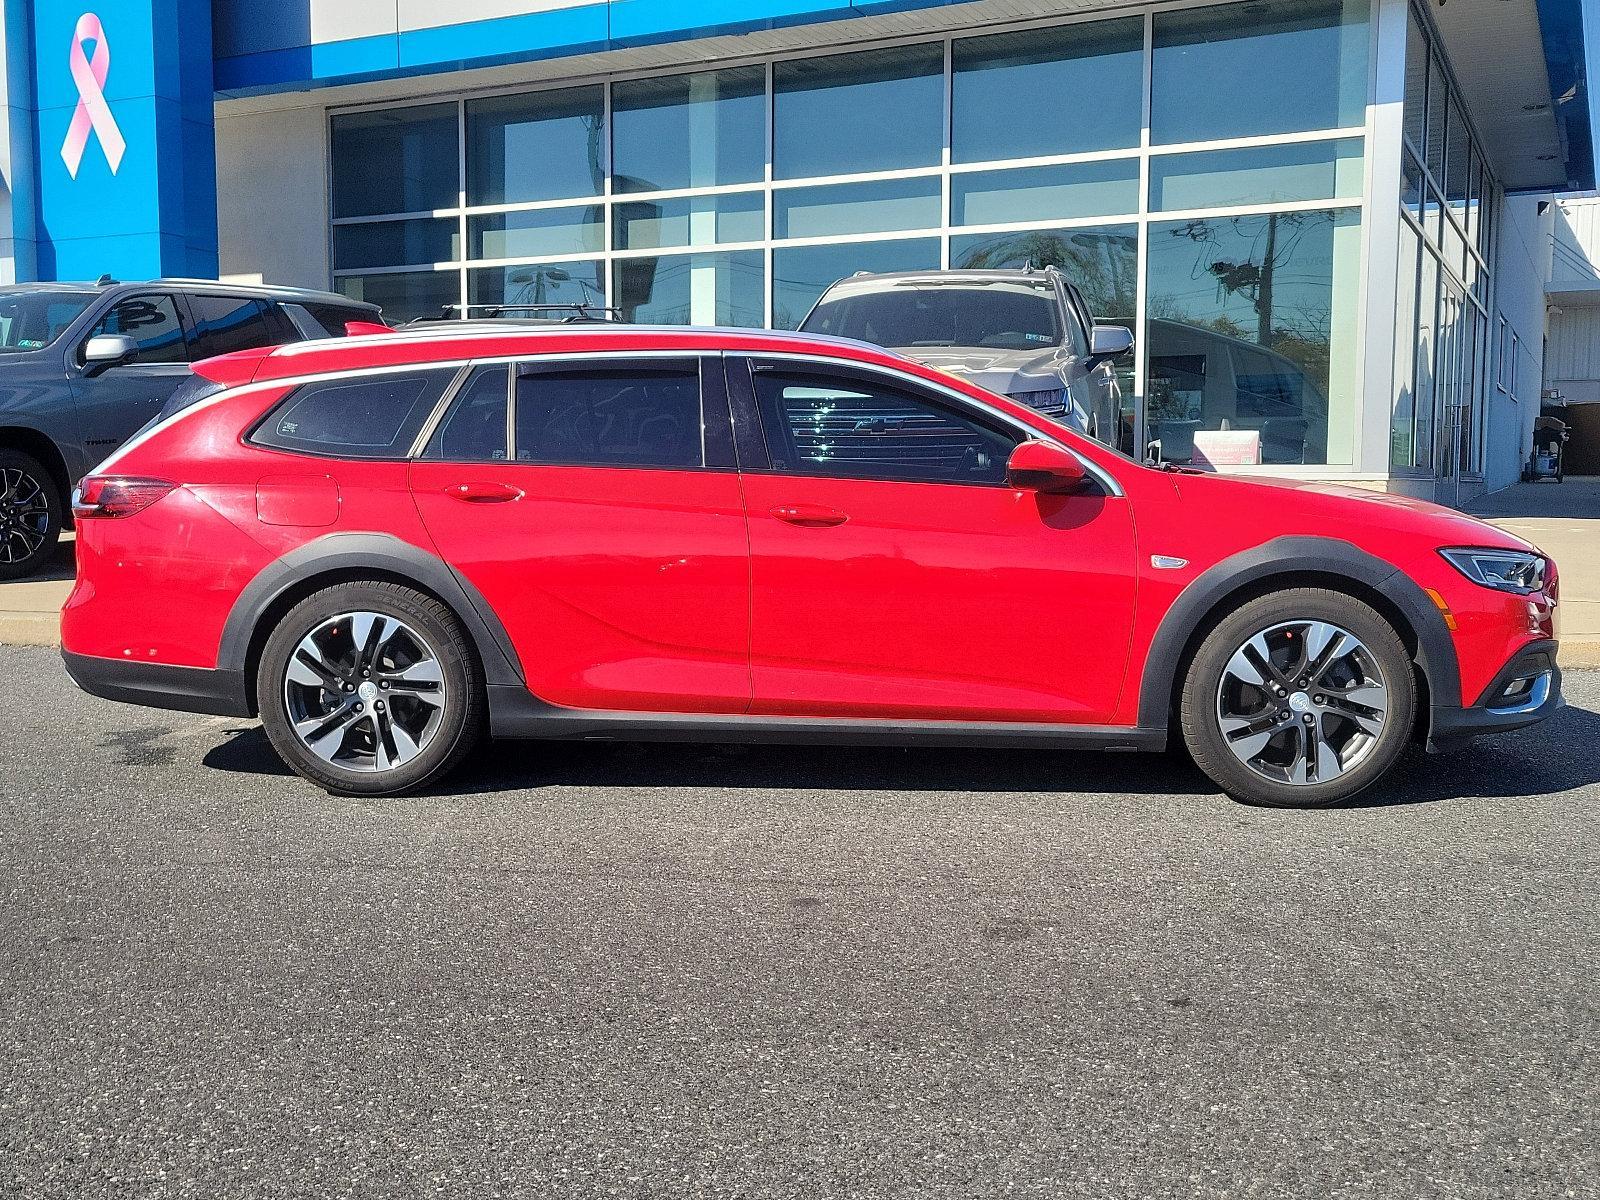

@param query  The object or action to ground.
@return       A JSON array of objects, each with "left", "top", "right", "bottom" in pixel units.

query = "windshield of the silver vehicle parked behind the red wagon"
[{"left": 805, "top": 282, "right": 1061, "bottom": 350}]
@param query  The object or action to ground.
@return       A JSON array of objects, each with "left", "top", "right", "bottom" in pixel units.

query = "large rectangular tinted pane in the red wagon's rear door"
[{"left": 515, "top": 362, "right": 706, "bottom": 469}]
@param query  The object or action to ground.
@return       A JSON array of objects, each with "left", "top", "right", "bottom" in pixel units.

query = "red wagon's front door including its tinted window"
[{"left": 728, "top": 358, "right": 1136, "bottom": 725}]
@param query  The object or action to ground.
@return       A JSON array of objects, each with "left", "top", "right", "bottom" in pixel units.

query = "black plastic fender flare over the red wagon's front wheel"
[{"left": 1139, "top": 538, "right": 1461, "bottom": 730}]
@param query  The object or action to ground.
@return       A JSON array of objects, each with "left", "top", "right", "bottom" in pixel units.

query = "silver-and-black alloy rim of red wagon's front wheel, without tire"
[{"left": 1216, "top": 621, "right": 1390, "bottom": 786}]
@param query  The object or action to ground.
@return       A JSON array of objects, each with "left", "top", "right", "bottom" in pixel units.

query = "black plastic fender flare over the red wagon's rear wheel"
[{"left": 218, "top": 533, "right": 523, "bottom": 686}]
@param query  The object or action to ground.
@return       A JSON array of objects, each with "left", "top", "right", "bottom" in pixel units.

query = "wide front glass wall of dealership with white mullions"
[{"left": 331, "top": 0, "right": 1376, "bottom": 466}]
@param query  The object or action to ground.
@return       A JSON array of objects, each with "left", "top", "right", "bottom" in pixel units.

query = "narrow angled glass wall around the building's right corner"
[{"left": 1389, "top": 1, "right": 1499, "bottom": 478}]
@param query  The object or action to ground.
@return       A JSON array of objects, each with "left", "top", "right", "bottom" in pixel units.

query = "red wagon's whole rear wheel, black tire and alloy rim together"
[{"left": 256, "top": 581, "right": 485, "bottom": 795}]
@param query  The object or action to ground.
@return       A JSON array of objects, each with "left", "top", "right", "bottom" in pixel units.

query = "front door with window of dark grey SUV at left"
[{"left": 67, "top": 291, "right": 189, "bottom": 461}]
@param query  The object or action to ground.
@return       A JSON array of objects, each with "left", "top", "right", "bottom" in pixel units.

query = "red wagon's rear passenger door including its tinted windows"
[{"left": 411, "top": 355, "right": 750, "bottom": 714}]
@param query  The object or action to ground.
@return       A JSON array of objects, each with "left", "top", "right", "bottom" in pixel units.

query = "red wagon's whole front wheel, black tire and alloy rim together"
[{"left": 1181, "top": 589, "right": 1416, "bottom": 808}]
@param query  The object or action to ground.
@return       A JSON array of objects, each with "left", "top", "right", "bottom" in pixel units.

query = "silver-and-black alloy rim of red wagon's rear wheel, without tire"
[{"left": 283, "top": 613, "right": 448, "bottom": 773}]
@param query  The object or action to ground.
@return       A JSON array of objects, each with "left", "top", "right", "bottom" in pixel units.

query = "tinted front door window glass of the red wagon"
[{"left": 752, "top": 363, "right": 1019, "bottom": 485}]
